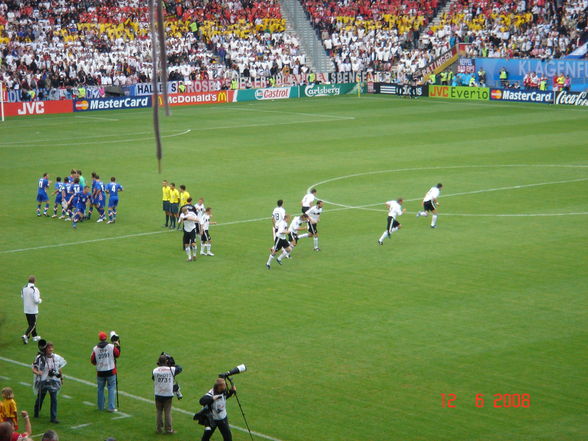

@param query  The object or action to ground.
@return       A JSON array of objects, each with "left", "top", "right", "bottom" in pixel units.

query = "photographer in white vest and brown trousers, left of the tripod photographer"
[{"left": 151, "top": 352, "right": 182, "bottom": 433}]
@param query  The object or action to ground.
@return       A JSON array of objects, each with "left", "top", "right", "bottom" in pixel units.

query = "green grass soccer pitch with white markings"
[{"left": 0, "top": 96, "right": 588, "bottom": 441}]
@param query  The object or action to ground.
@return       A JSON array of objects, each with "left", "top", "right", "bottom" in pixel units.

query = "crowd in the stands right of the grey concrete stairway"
[{"left": 303, "top": 0, "right": 588, "bottom": 81}]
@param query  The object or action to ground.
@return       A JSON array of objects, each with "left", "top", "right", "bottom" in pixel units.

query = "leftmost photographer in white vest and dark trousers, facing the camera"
[{"left": 33, "top": 339, "right": 67, "bottom": 424}]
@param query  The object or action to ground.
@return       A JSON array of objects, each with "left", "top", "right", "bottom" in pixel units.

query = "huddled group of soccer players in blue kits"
[{"left": 37, "top": 169, "right": 123, "bottom": 229}]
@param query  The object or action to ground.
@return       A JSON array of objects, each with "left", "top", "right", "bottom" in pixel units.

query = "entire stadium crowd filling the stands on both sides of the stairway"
[{"left": 0, "top": 0, "right": 588, "bottom": 100}]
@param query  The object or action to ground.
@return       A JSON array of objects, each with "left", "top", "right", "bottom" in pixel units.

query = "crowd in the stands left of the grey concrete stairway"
[{"left": 0, "top": 0, "right": 308, "bottom": 99}]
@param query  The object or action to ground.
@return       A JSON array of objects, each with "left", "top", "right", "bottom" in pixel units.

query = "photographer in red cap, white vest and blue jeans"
[{"left": 90, "top": 331, "right": 120, "bottom": 412}]
